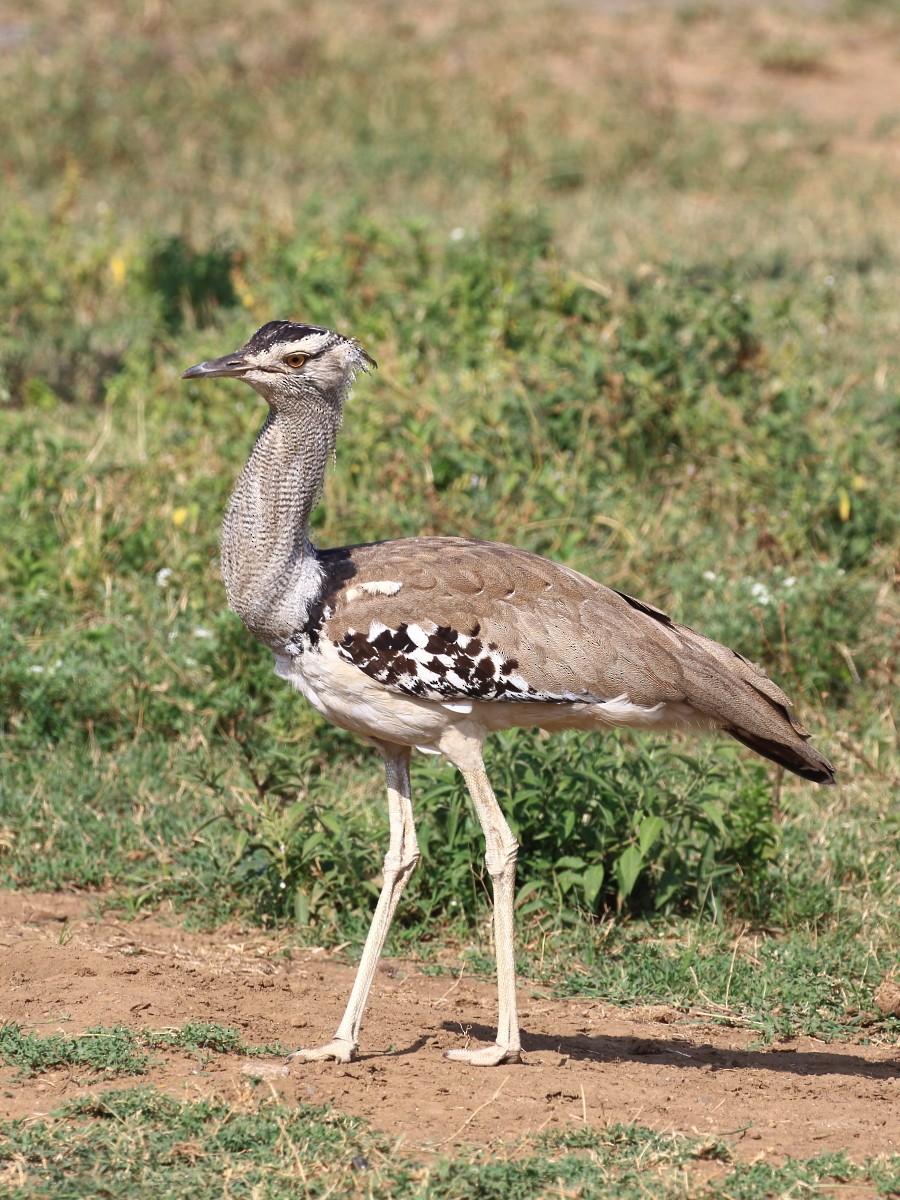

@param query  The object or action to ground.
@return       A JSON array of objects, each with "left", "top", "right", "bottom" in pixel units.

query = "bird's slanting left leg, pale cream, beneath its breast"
[{"left": 289, "top": 742, "right": 419, "bottom": 1062}]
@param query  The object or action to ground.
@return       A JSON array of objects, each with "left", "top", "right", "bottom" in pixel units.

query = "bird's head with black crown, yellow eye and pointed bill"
[{"left": 181, "top": 320, "right": 376, "bottom": 420}]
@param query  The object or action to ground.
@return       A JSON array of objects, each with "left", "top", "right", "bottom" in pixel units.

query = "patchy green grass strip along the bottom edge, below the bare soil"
[{"left": 0, "top": 1088, "right": 900, "bottom": 1200}]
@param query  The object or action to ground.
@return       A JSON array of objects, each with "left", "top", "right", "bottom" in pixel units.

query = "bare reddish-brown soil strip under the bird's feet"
[{"left": 0, "top": 893, "right": 900, "bottom": 1159}]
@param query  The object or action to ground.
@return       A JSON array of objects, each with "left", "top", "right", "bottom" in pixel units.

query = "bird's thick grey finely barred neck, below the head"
[{"left": 222, "top": 410, "right": 336, "bottom": 650}]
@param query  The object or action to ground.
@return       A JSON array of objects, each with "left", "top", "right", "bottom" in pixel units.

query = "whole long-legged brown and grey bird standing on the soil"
[{"left": 182, "top": 319, "right": 835, "bottom": 1067}]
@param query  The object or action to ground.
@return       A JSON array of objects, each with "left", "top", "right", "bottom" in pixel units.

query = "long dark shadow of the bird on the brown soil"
[{"left": 443, "top": 1021, "right": 900, "bottom": 1079}]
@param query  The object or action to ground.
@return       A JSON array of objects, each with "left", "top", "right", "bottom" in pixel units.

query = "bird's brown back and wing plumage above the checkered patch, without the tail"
[{"left": 316, "top": 538, "right": 684, "bottom": 706}]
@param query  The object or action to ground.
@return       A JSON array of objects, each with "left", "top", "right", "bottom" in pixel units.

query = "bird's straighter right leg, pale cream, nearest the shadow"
[{"left": 440, "top": 731, "right": 522, "bottom": 1067}]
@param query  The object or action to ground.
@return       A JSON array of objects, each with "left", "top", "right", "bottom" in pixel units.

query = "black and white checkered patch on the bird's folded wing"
[{"left": 336, "top": 622, "right": 589, "bottom": 703}]
